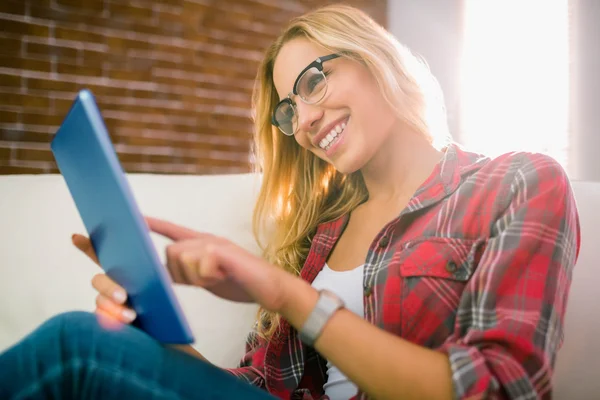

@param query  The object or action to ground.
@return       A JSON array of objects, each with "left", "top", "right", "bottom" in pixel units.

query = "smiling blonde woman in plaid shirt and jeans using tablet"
[{"left": 0, "top": 6, "right": 580, "bottom": 399}]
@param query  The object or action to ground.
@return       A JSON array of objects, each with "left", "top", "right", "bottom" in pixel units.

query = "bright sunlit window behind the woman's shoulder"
[{"left": 460, "top": 0, "right": 569, "bottom": 168}]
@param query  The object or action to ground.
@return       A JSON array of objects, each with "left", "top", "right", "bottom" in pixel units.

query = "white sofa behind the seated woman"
[{"left": 0, "top": 174, "right": 600, "bottom": 400}]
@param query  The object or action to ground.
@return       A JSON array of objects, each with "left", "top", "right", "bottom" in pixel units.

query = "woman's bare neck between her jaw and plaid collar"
[{"left": 361, "top": 126, "right": 442, "bottom": 203}]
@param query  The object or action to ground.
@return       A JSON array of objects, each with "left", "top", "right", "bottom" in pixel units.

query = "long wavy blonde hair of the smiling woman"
[{"left": 252, "top": 5, "right": 449, "bottom": 339}]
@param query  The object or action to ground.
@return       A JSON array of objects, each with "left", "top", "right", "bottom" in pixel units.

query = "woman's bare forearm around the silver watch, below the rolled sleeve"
[{"left": 282, "top": 281, "right": 452, "bottom": 399}]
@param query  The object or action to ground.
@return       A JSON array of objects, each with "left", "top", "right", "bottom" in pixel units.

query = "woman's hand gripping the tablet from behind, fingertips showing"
[{"left": 72, "top": 234, "right": 136, "bottom": 324}]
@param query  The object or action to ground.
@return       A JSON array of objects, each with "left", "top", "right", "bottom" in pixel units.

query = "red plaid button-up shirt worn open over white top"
[{"left": 229, "top": 145, "right": 580, "bottom": 399}]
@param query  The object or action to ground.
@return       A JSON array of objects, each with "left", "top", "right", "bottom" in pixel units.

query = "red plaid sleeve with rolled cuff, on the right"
[{"left": 440, "top": 153, "right": 580, "bottom": 399}]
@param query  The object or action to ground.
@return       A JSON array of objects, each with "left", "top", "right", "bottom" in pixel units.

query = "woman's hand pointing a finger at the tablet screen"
[{"left": 146, "top": 217, "right": 292, "bottom": 312}]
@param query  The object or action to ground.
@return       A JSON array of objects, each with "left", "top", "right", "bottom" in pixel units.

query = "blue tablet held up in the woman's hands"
[{"left": 50, "top": 90, "right": 194, "bottom": 344}]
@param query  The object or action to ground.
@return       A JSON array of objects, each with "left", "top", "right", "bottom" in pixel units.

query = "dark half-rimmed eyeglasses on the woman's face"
[{"left": 271, "top": 54, "right": 340, "bottom": 136}]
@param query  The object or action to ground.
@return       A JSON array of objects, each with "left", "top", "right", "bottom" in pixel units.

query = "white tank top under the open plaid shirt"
[{"left": 312, "top": 264, "right": 365, "bottom": 400}]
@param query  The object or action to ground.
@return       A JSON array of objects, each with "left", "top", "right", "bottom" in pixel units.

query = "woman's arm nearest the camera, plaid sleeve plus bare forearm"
[{"left": 281, "top": 155, "right": 579, "bottom": 399}]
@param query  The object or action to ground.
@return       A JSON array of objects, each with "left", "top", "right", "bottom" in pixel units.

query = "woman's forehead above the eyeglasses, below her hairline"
[{"left": 273, "top": 38, "right": 329, "bottom": 99}]
